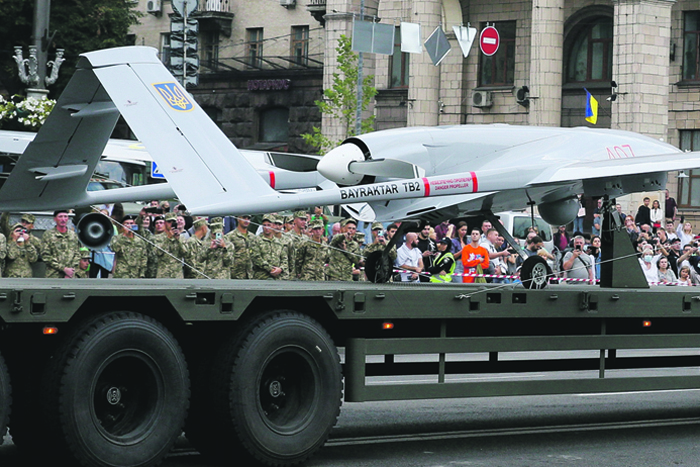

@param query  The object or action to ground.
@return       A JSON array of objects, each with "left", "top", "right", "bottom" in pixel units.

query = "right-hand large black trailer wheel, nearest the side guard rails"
[{"left": 213, "top": 311, "right": 342, "bottom": 466}]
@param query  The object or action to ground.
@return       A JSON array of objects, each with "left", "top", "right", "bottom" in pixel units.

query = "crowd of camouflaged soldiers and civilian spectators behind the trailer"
[{"left": 0, "top": 191, "right": 700, "bottom": 285}]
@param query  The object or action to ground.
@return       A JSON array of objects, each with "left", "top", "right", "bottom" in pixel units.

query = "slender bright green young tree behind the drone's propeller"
[{"left": 301, "top": 35, "right": 377, "bottom": 154}]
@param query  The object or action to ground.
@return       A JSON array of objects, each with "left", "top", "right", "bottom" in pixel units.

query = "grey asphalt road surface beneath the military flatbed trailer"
[{"left": 0, "top": 356, "right": 700, "bottom": 467}]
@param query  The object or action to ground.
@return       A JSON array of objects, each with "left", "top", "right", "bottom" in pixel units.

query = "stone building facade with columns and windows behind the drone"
[{"left": 129, "top": 0, "right": 700, "bottom": 223}]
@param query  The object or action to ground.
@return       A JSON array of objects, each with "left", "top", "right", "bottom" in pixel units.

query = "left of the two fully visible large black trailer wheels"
[{"left": 43, "top": 312, "right": 189, "bottom": 467}]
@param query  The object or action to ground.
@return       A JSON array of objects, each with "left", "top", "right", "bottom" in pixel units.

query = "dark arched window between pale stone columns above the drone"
[{"left": 566, "top": 16, "right": 613, "bottom": 83}]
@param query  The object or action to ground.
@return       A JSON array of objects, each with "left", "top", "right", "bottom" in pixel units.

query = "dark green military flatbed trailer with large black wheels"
[{"left": 0, "top": 279, "right": 700, "bottom": 466}]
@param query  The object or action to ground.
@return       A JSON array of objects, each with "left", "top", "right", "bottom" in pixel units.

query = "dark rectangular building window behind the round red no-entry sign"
[{"left": 479, "top": 21, "right": 515, "bottom": 86}]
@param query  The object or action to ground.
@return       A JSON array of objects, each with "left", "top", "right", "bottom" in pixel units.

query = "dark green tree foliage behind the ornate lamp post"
[{"left": 0, "top": 0, "right": 141, "bottom": 97}]
